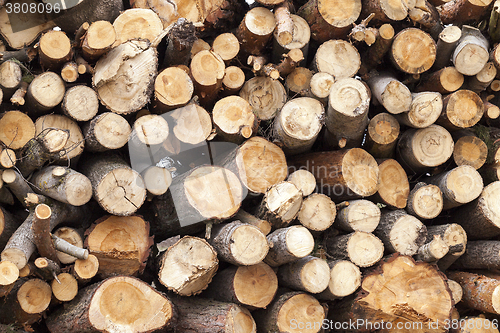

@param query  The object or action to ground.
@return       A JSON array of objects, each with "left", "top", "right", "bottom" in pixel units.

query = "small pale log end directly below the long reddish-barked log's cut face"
[{"left": 334, "top": 199, "right": 380, "bottom": 232}]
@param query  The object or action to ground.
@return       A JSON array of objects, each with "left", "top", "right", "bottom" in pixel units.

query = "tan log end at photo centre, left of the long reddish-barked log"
[{"left": 222, "top": 137, "right": 288, "bottom": 194}]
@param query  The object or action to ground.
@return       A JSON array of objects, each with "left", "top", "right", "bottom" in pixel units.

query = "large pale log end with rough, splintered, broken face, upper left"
[{"left": 92, "top": 40, "right": 158, "bottom": 114}]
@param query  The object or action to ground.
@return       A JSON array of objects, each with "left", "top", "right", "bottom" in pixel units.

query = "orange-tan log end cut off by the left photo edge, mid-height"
[{"left": 0, "top": 111, "right": 35, "bottom": 150}]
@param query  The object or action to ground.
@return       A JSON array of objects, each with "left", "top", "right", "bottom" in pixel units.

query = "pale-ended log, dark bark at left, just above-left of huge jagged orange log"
[{"left": 325, "top": 231, "right": 384, "bottom": 267}]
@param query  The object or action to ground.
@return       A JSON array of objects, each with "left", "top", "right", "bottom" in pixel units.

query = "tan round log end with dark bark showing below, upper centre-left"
[{"left": 190, "top": 50, "right": 226, "bottom": 105}]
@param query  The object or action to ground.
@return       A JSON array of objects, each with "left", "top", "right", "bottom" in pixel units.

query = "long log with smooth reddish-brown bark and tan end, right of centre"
[{"left": 290, "top": 148, "right": 379, "bottom": 199}]
